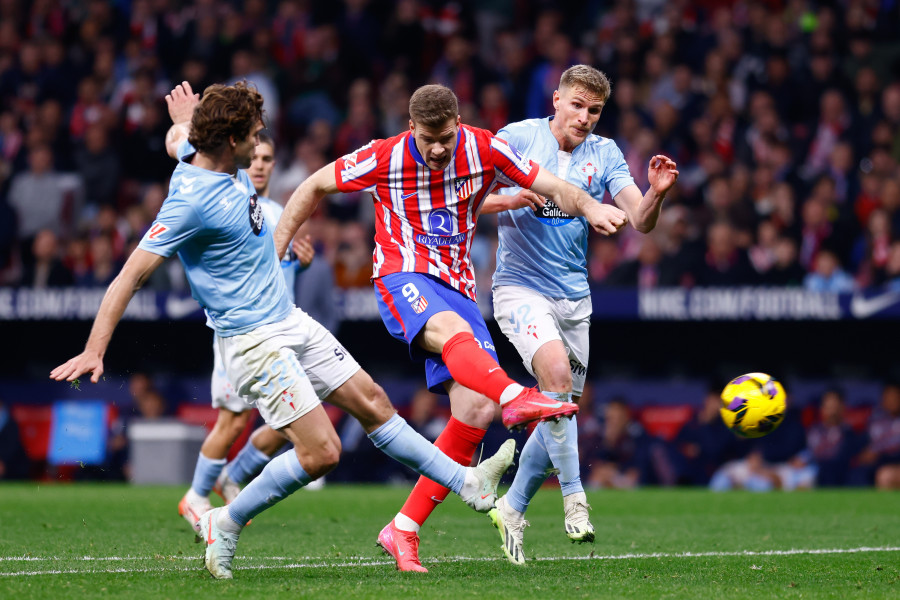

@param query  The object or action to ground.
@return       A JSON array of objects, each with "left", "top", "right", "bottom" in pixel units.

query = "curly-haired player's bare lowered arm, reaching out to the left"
[{"left": 50, "top": 248, "right": 165, "bottom": 383}]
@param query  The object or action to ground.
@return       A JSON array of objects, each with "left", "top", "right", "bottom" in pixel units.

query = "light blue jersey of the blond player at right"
[{"left": 494, "top": 117, "right": 634, "bottom": 300}]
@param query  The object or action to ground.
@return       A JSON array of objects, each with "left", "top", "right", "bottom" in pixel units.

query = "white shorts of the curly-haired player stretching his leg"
[{"left": 216, "top": 308, "right": 360, "bottom": 429}]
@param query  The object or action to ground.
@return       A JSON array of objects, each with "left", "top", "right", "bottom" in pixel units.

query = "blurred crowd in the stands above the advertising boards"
[{"left": 0, "top": 0, "right": 900, "bottom": 292}]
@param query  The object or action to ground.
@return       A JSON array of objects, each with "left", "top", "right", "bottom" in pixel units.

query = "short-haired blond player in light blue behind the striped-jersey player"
[{"left": 486, "top": 65, "right": 678, "bottom": 564}]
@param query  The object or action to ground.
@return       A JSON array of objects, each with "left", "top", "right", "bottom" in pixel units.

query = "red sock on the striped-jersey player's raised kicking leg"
[{"left": 441, "top": 332, "right": 515, "bottom": 404}]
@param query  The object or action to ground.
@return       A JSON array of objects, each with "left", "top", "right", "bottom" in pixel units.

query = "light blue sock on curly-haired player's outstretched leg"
[{"left": 369, "top": 413, "right": 466, "bottom": 494}]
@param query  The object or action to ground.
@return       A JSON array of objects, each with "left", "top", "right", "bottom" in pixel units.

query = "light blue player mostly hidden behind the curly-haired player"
[{"left": 178, "top": 131, "right": 322, "bottom": 526}]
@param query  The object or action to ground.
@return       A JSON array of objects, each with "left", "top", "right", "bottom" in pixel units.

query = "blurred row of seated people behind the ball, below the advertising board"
[{"left": 578, "top": 382, "right": 900, "bottom": 492}]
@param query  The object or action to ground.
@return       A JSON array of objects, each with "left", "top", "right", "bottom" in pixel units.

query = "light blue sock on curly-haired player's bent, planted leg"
[{"left": 228, "top": 451, "right": 312, "bottom": 525}]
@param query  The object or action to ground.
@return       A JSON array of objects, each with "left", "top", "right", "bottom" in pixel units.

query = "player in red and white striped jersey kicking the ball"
[{"left": 275, "top": 85, "right": 627, "bottom": 571}]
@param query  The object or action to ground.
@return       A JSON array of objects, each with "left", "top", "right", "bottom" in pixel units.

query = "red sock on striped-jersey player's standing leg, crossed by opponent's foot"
[{"left": 400, "top": 417, "right": 486, "bottom": 525}]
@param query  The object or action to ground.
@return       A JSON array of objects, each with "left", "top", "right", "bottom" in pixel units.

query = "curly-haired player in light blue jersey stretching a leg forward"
[{"left": 50, "top": 82, "right": 515, "bottom": 579}]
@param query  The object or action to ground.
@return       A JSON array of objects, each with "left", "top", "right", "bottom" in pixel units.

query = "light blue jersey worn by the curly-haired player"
[{"left": 138, "top": 142, "right": 293, "bottom": 337}]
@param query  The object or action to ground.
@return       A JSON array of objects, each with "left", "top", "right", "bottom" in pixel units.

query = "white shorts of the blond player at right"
[{"left": 494, "top": 285, "right": 593, "bottom": 396}]
